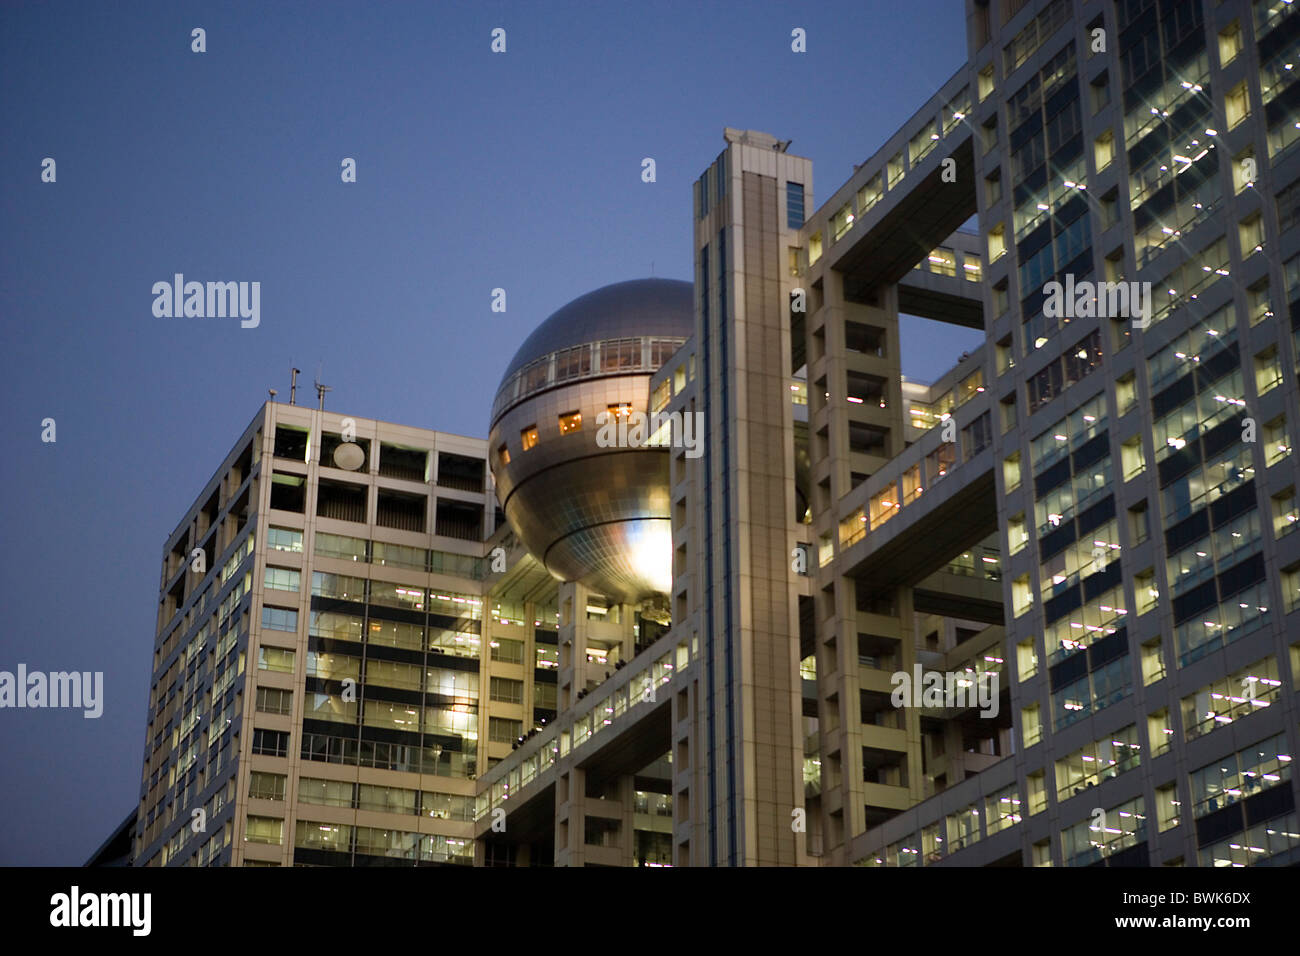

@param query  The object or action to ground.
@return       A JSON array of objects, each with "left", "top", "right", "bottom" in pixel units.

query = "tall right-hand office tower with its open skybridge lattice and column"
[{"left": 476, "top": 0, "right": 1300, "bottom": 866}]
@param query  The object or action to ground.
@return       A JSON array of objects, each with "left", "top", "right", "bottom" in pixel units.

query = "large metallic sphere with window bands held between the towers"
[{"left": 489, "top": 278, "right": 694, "bottom": 602}]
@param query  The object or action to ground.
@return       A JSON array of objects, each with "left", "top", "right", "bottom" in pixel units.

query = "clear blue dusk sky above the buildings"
[{"left": 0, "top": 0, "right": 979, "bottom": 865}]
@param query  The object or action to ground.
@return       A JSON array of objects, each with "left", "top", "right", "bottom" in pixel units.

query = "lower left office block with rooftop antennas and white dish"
[{"left": 133, "top": 403, "right": 496, "bottom": 866}]
